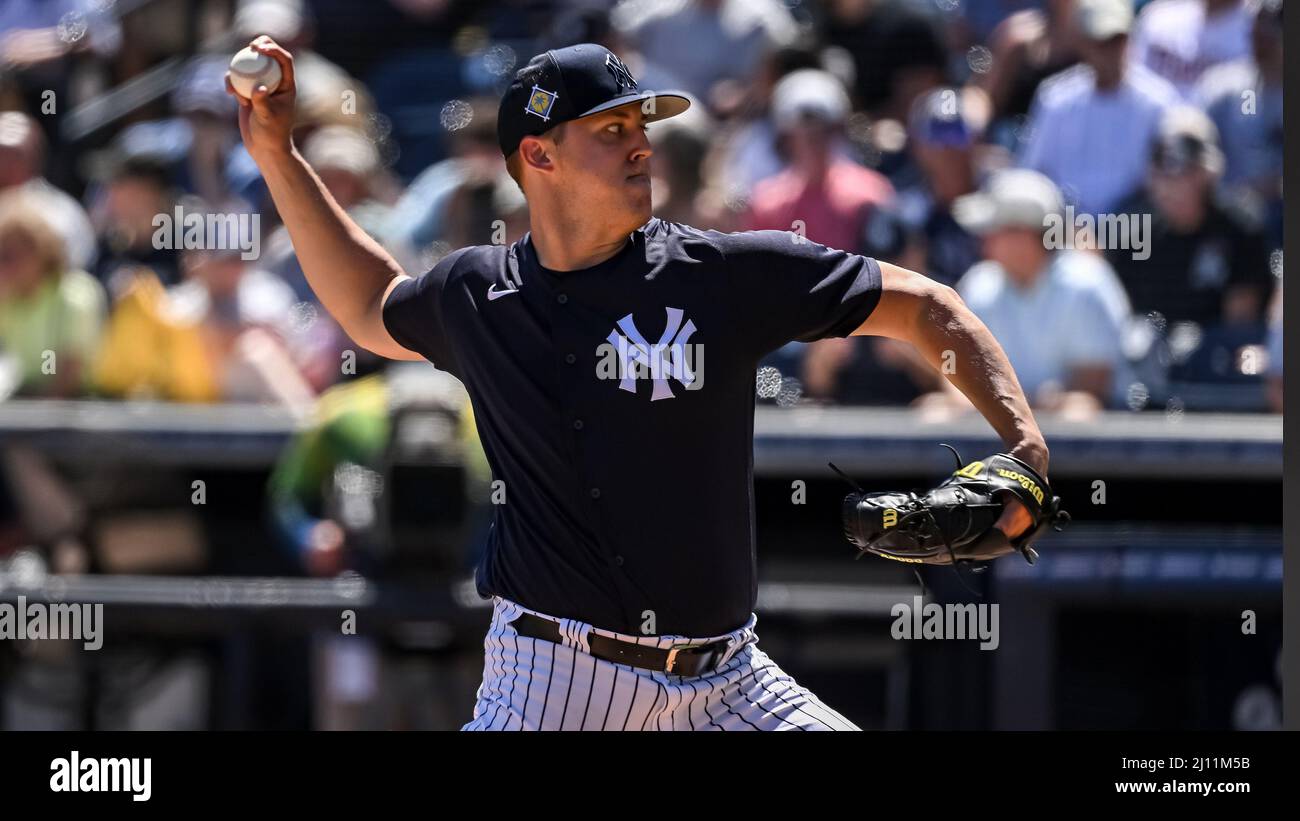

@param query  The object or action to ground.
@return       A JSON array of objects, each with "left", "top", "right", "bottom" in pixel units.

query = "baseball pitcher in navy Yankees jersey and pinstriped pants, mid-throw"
[{"left": 231, "top": 38, "right": 1058, "bottom": 730}]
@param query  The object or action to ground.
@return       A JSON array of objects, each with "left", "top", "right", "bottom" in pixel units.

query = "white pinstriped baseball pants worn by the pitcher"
[{"left": 462, "top": 596, "right": 858, "bottom": 730}]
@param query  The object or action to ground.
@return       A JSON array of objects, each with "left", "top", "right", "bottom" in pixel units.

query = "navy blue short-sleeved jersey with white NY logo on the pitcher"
[{"left": 384, "top": 218, "right": 880, "bottom": 637}]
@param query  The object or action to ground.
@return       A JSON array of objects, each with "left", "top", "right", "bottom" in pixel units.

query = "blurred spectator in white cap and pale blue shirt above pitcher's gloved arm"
[{"left": 930, "top": 169, "right": 1130, "bottom": 414}]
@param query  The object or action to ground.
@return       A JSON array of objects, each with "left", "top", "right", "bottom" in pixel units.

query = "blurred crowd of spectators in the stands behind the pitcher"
[{"left": 0, "top": 0, "right": 1283, "bottom": 416}]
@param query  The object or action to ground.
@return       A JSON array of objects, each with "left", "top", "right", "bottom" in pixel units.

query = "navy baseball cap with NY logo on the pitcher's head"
[{"left": 497, "top": 43, "right": 690, "bottom": 157}]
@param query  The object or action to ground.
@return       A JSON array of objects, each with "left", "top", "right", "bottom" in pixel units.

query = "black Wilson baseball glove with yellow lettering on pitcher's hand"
[{"left": 832, "top": 444, "right": 1070, "bottom": 565}]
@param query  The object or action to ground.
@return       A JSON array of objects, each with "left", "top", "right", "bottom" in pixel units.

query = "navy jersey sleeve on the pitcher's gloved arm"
[{"left": 718, "top": 231, "right": 881, "bottom": 357}]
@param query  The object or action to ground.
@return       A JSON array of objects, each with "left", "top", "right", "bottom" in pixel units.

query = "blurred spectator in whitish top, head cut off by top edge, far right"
[{"left": 1128, "top": 0, "right": 1256, "bottom": 97}]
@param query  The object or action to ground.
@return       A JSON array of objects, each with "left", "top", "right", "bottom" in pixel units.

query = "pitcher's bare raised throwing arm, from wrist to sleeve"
[{"left": 261, "top": 148, "right": 420, "bottom": 359}]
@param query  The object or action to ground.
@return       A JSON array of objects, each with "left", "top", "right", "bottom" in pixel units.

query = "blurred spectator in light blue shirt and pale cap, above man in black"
[{"left": 1021, "top": 0, "right": 1178, "bottom": 214}]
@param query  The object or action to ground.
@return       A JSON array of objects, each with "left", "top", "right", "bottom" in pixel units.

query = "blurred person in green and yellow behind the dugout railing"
[{"left": 268, "top": 353, "right": 490, "bottom": 730}]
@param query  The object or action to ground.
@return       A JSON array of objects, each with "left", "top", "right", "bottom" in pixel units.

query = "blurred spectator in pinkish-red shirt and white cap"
[{"left": 745, "top": 69, "right": 893, "bottom": 252}]
